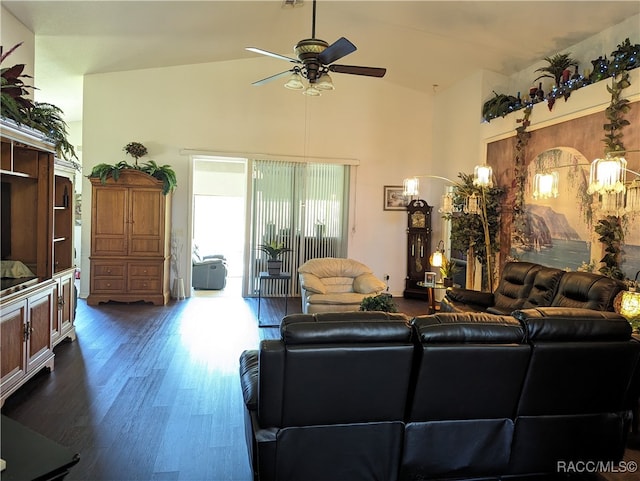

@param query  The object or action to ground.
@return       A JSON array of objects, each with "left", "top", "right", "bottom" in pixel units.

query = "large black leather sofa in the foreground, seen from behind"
[{"left": 240, "top": 307, "right": 640, "bottom": 481}]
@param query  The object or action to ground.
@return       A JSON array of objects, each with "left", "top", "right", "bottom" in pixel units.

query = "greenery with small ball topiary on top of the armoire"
[{"left": 87, "top": 142, "right": 178, "bottom": 195}]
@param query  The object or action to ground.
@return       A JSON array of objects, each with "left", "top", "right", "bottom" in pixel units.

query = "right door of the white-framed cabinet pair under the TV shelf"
[{"left": 27, "top": 285, "right": 56, "bottom": 371}]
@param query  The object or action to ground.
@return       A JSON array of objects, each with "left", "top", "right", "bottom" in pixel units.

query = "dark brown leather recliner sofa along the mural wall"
[{"left": 440, "top": 262, "right": 625, "bottom": 314}]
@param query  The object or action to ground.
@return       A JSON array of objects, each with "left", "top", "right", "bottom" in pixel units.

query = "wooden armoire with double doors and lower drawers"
[{"left": 87, "top": 169, "right": 171, "bottom": 305}]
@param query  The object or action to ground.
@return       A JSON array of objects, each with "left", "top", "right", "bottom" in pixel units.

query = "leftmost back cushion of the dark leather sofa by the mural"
[{"left": 494, "top": 262, "right": 542, "bottom": 312}]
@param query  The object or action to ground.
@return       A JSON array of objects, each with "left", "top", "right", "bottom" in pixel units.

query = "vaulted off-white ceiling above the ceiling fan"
[{"left": 2, "top": 0, "right": 640, "bottom": 121}]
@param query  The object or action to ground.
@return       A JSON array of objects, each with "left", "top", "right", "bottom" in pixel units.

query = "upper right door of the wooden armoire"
[{"left": 129, "top": 188, "right": 165, "bottom": 256}]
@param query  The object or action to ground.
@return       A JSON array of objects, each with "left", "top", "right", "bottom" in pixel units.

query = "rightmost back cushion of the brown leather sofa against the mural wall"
[{"left": 551, "top": 272, "right": 624, "bottom": 311}]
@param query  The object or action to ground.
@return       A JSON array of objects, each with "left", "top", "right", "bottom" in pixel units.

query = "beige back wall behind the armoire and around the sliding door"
[{"left": 80, "top": 59, "right": 431, "bottom": 296}]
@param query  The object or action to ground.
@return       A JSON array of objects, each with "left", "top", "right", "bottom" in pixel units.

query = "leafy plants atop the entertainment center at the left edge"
[{"left": 0, "top": 42, "right": 79, "bottom": 161}]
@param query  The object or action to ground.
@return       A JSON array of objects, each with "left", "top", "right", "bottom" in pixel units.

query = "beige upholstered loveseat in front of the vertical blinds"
[{"left": 298, "top": 257, "right": 386, "bottom": 314}]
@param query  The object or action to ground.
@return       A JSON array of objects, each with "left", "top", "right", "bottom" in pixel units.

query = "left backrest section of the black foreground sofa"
[{"left": 258, "top": 311, "right": 414, "bottom": 427}]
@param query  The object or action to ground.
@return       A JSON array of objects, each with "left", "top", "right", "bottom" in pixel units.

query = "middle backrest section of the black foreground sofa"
[{"left": 409, "top": 313, "right": 530, "bottom": 422}]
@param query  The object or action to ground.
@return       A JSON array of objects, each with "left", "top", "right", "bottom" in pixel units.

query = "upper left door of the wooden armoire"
[{"left": 91, "top": 185, "right": 129, "bottom": 256}]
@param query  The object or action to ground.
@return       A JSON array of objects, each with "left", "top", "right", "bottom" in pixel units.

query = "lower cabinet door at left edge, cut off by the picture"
[{"left": 0, "top": 299, "right": 27, "bottom": 392}]
